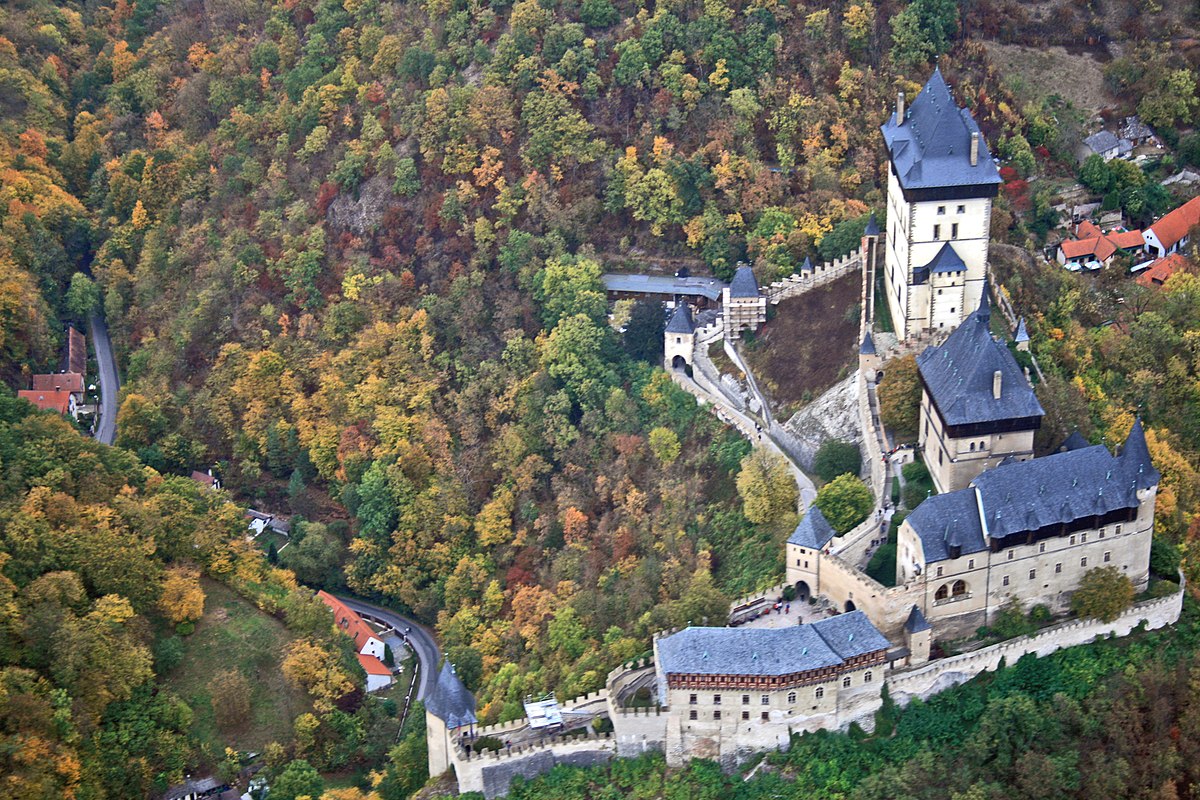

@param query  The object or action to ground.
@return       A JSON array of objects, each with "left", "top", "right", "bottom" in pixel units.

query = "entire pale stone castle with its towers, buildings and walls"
[{"left": 426, "top": 70, "right": 1182, "bottom": 798}]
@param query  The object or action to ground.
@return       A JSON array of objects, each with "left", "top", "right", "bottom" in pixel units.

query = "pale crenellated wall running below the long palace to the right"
[{"left": 887, "top": 589, "right": 1183, "bottom": 705}]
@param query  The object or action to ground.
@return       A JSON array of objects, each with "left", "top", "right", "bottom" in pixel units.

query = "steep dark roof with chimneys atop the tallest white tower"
[{"left": 882, "top": 70, "right": 1000, "bottom": 190}]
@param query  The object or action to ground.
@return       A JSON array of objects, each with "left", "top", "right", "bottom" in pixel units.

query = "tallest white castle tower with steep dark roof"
[{"left": 882, "top": 70, "right": 1000, "bottom": 339}]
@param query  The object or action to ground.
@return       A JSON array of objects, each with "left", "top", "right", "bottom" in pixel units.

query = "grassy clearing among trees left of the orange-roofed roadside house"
[{"left": 164, "top": 578, "right": 311, "bottom": 756}]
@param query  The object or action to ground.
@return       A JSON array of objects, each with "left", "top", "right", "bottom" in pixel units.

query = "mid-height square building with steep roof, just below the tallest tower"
[{"left": 917, "top": 291, "right": 1045, "bottom": 493}]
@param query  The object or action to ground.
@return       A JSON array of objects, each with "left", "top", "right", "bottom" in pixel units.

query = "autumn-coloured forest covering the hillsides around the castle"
[{"left": 0, "top": 0, "right": 1200, "bottom": 800}]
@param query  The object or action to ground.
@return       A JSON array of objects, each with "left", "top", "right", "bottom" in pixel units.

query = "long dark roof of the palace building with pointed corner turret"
[{"left": 908, "top": 420, "right": 1160, "bottom": 563}]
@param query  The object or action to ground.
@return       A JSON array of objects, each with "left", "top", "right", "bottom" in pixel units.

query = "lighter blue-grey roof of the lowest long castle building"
[{"left": 659, "top": 612, "right": 890, "bottom": 676}]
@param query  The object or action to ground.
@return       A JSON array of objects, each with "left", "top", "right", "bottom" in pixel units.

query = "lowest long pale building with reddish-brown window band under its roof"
[{"left": 654, "top": 612, "right": 892, "bottom": 765}]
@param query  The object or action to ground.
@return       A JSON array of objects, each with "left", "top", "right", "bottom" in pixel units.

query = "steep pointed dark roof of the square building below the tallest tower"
[{"left": 917, "top": 290, "right": 1045, "bottom": 425}]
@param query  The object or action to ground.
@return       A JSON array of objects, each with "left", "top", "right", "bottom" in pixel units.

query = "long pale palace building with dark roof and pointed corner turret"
[{"left": 896, "top": 420, "right": 1159, "bottom": 636}]
